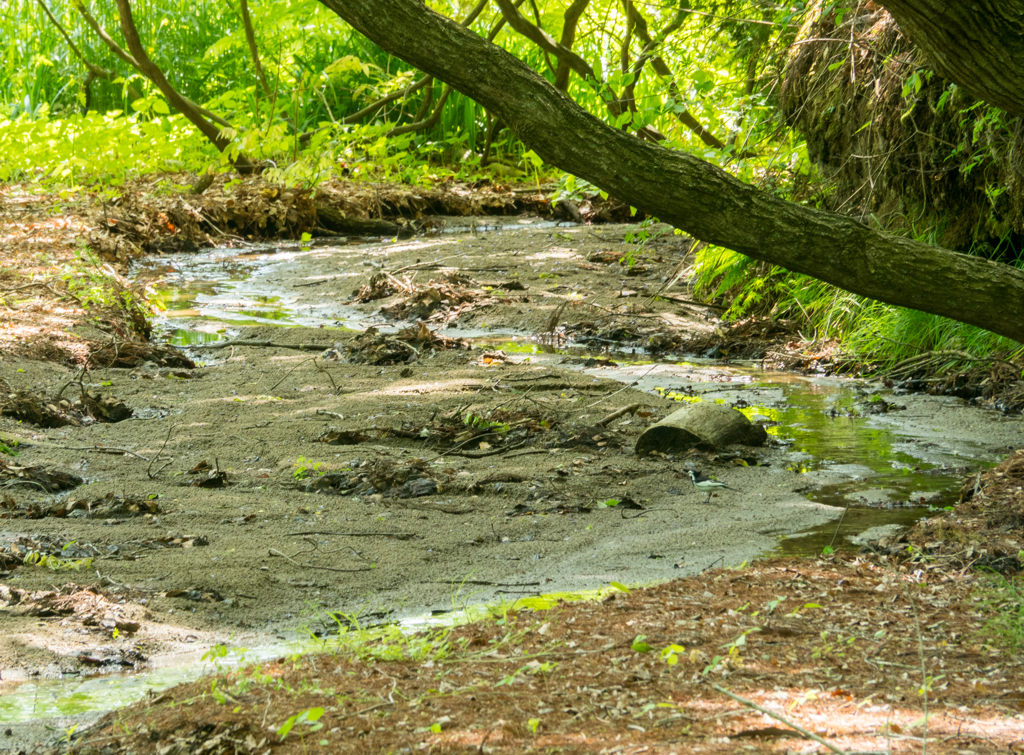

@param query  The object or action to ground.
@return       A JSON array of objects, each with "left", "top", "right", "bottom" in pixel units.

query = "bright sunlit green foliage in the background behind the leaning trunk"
[{"left": 0, "top": 0, "right": 805, "bottom": 193}]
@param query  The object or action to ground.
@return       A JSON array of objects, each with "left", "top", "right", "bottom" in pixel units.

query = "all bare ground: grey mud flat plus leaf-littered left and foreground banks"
[{"left": 0, "top": 178, "right": 1024, "bottom": 753}]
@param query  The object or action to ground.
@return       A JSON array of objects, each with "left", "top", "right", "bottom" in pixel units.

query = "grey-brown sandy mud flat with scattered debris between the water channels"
[{"left": 0, "top": 218, "right": 835, "bottom": 678}]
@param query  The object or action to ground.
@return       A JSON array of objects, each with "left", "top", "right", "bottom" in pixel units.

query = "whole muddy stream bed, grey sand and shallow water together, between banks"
[{"left": 0, "top": 221, "right": 1024, "bottom": 749}]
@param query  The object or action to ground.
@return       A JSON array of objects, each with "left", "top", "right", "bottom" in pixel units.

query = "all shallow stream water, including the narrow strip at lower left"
[{"left": 9, "top": 239, "right": 1001, "bottom": 729}]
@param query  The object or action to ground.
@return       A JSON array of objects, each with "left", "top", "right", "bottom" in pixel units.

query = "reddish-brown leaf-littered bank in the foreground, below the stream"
[{"left": 48, "top": 557, "right": 1024, "bottom": 755}]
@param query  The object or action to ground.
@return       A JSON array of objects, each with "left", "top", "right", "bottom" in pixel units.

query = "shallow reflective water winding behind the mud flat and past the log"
[{"left": 139, "top": 244, "right": 997, "bottom": 555}]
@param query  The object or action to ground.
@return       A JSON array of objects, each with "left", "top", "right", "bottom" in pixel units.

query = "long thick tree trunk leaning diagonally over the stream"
[{"left": 323, "top": 0, "right": 1024, "bottom": 342}]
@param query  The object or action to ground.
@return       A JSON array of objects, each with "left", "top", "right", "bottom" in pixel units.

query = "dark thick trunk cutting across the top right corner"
[{"left": 879, "top": 0, "right": 1024, "bottom": 118}]
